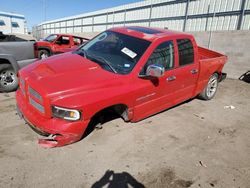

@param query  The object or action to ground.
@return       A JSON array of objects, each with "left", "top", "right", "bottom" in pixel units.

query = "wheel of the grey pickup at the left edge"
[{"left": 0, "top": 64, "right": 18, "bottom": 92}]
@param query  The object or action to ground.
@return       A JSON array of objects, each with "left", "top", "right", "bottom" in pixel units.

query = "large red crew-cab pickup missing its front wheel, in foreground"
[{"left": 16, "top": 26, "right": 227, "bottom": 147}]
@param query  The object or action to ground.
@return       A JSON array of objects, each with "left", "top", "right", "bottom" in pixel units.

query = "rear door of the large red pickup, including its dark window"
[{"left": 174, "top": 38, "right": 199, "bottom": 104}]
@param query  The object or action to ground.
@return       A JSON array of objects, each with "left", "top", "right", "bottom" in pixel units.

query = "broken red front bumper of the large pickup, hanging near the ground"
[{"left": 16, "top": 90, "right": 89, "bottom": 148}]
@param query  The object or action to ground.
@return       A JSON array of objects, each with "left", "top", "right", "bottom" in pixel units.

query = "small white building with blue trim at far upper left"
[{"left": 0, "top": 12, "right": 27, "bottom": 34}]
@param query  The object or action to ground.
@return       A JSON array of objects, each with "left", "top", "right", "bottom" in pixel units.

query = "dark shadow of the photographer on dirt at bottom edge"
[{"left": 91, "top": 170, "right": 145, "bottom": 188}]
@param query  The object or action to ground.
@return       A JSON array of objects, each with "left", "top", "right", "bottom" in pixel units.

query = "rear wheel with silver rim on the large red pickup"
[{"left": 198, "top": 73, "right": 219, "bottom": 101}]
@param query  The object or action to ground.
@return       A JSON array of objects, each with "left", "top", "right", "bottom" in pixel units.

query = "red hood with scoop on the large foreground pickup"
[{"left": 20, "top": 52, "right": 126, "bottom": 98}]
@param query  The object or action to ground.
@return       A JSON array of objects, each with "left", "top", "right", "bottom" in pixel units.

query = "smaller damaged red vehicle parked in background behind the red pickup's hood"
[{"left": 35, "top": 34, "right": 89, "bottom": 59}]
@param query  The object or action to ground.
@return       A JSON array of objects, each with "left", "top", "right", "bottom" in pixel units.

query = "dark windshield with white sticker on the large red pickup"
[{"left": 75, "top": 31, "right": 150, "bottom": 74}]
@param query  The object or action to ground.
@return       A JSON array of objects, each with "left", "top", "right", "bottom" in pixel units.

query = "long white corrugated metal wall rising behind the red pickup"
[{"left": 33, "top": 0, "right": 250, "bottom": 38}]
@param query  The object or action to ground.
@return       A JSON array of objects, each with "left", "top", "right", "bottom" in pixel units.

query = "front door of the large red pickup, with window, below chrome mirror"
[{"left": 134, "top": 41, "right": 177, "bottom": 121}]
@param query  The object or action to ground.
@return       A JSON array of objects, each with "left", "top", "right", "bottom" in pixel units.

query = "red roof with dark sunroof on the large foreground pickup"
[{"left": 110, "top": 26, "right": 191, "bottom": 42}]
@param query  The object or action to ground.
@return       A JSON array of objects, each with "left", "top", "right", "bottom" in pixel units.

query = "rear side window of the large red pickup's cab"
[{"left": 177, "top": 39, "right": 194, "bottom": 66}]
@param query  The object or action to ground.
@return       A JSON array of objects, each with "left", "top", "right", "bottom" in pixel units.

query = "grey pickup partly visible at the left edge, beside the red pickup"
[{"left": 0, "top": 42, "right": 36, "bottom": 92}]
